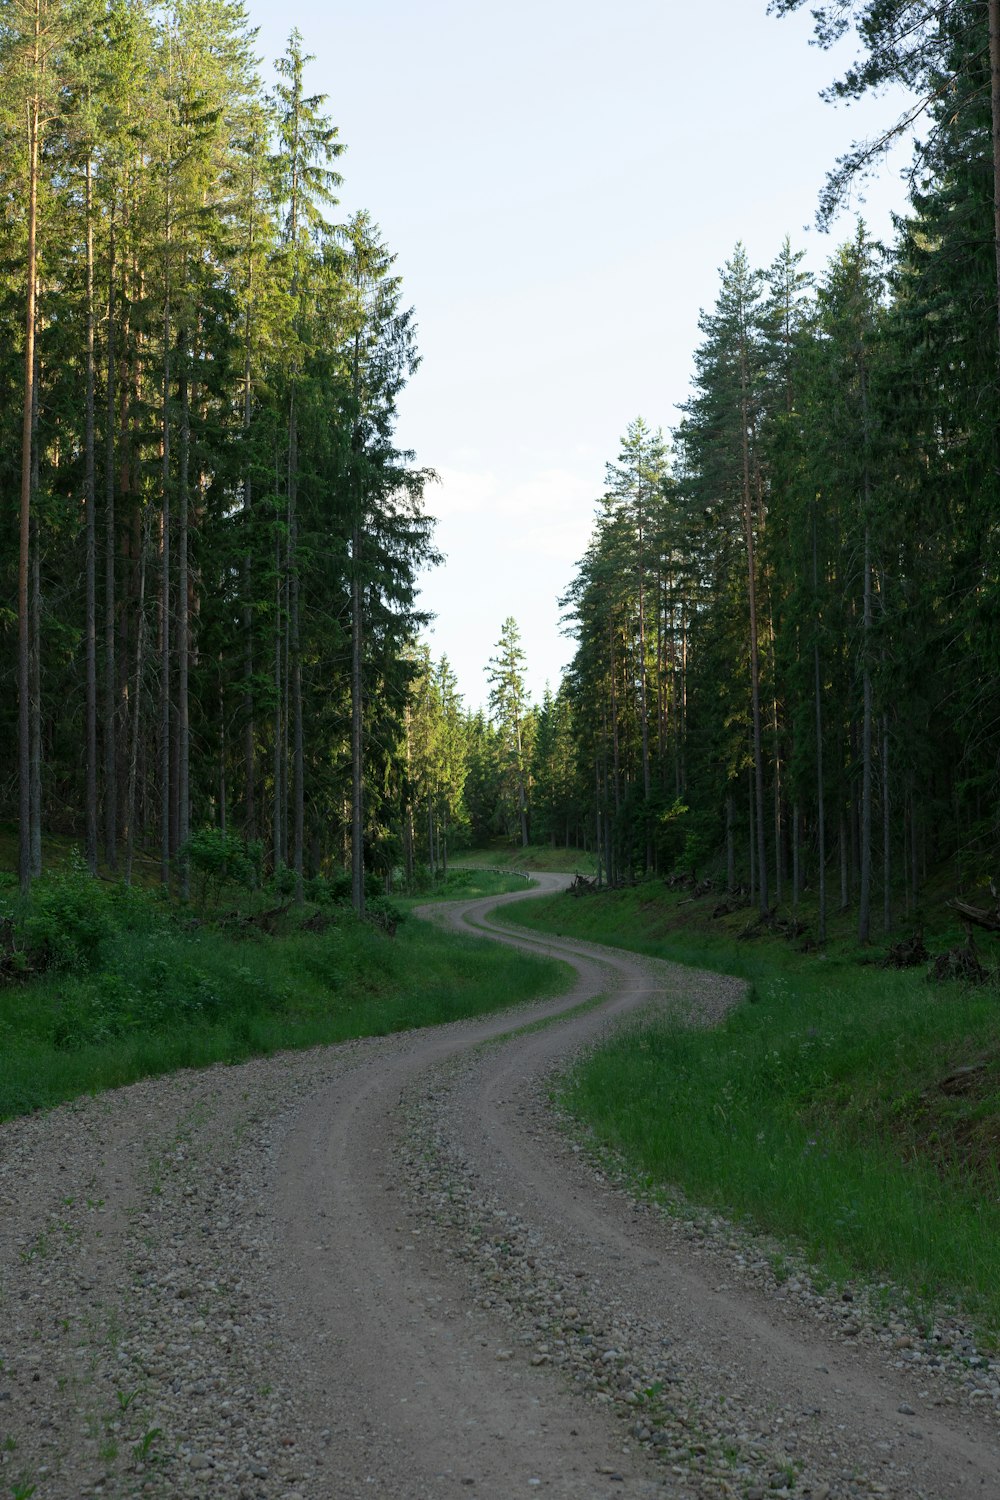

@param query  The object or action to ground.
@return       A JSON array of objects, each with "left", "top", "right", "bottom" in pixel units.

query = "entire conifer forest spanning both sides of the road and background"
[{"left": 0, "top": 0, "right": 1000, "bottom": 944}]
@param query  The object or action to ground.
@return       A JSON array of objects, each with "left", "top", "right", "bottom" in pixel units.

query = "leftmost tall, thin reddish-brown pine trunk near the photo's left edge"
[{"left": 18, "top": 26, "right": 42, "bottom": 894}]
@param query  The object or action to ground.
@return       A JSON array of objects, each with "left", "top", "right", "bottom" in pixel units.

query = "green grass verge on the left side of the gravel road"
[{"left": 0, "top": 888, "right": 568, "bottom": 1119}]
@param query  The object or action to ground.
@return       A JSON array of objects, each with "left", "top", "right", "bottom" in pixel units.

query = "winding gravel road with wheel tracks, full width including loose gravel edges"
[{"left": 0, "top": 876, "right": 1000, "bottom": 1500}]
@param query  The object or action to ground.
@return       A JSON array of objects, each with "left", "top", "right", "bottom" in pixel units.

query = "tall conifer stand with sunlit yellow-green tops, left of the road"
[{"left": 0, "top": 0, "right": 433, "bottom": 906}]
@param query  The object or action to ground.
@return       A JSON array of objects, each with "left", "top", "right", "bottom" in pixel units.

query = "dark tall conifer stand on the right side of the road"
[{"left": 467, "top": 0, "right": 1000, "bottom": 944}]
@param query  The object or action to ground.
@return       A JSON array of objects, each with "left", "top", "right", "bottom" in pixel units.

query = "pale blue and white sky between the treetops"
[{"left": 247, "top": 0, "right": 907, "bottom": 710}]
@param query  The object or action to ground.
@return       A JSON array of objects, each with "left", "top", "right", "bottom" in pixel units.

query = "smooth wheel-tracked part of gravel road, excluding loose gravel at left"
[{"left": 274, "top": 876, "right": 1000, "bottom": 1500}]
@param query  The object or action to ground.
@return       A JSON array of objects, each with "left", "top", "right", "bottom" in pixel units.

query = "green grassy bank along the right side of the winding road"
[{"left": 505, "top": 884, "right": 1000, "bottom": 1341}]
